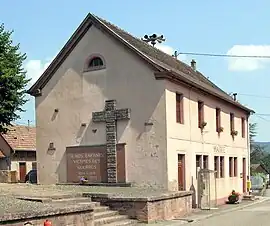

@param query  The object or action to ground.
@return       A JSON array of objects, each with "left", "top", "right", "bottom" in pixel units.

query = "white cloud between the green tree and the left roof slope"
[{"left": 24, "top": 58, "right": 53, "bottom": 85}]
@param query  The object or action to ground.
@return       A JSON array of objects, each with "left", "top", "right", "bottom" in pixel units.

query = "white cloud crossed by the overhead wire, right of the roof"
[{"left": 227, "top": 45, "right": 270, "bottom": 71}]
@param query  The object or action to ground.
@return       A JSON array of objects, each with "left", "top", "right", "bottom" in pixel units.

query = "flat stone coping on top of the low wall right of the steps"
[{"left": 82, "top": 191, "right": 192, "bottom": 202}]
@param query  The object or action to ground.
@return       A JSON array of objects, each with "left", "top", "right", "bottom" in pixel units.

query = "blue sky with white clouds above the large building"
[{"left": 0, "top": 0, "right": 270, "bottom": 141}]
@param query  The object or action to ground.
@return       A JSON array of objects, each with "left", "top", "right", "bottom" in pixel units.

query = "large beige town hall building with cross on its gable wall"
[{"left": 28, "top": 14, "right": 253, "bottom": 206}]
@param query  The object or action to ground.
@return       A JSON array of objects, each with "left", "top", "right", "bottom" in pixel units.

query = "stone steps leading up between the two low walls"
[{"left": 52, "top": 197, "right": 138, "bottom": 226}]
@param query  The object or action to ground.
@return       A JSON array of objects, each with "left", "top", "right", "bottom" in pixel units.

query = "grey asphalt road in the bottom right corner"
[{"left": 183, "top": 189, "right": 270, "bottom": 226}]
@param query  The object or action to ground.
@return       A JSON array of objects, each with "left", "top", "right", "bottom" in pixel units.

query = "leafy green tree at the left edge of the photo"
[{"left": 0, "top": 24, "right": 30, "bottom": 133}]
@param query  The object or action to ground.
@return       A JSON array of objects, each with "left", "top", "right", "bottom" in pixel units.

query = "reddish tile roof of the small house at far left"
[{"left": 3, "top": 125, "right": 36, "bottom": 151}]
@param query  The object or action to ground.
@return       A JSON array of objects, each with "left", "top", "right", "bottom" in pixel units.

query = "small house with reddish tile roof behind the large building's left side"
[{"left": 1, "top": 125, "right": 36, "bottom": 182}]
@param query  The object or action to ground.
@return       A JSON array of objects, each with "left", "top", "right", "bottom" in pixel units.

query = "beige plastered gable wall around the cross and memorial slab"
[{"left": 36, "top": 26, "right": 167, "bottom": 187}]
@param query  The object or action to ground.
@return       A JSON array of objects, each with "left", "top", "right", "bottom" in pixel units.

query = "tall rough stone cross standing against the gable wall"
[{"left": 92, "top": 100, "right": 130, "bottom": 183}]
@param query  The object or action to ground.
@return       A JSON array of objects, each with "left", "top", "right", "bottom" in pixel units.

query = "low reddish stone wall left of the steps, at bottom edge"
[{"left": 0, "top": 211, "right": 94, "bottom": 226}]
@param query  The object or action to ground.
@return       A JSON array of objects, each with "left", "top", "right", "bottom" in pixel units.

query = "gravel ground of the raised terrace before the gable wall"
[{"left": 0, "top": 183, "right": 174, "bottom": 216}]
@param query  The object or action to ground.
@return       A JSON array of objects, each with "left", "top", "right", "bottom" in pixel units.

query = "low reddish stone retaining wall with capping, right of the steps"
[{"left": 83, "top": 191, "right": 192, "bottom": 223}]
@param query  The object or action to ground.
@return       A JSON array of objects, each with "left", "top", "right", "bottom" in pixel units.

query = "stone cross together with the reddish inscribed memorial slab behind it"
[{"left": 66, "top": 100, "right": 130, "bottom": 183}]
